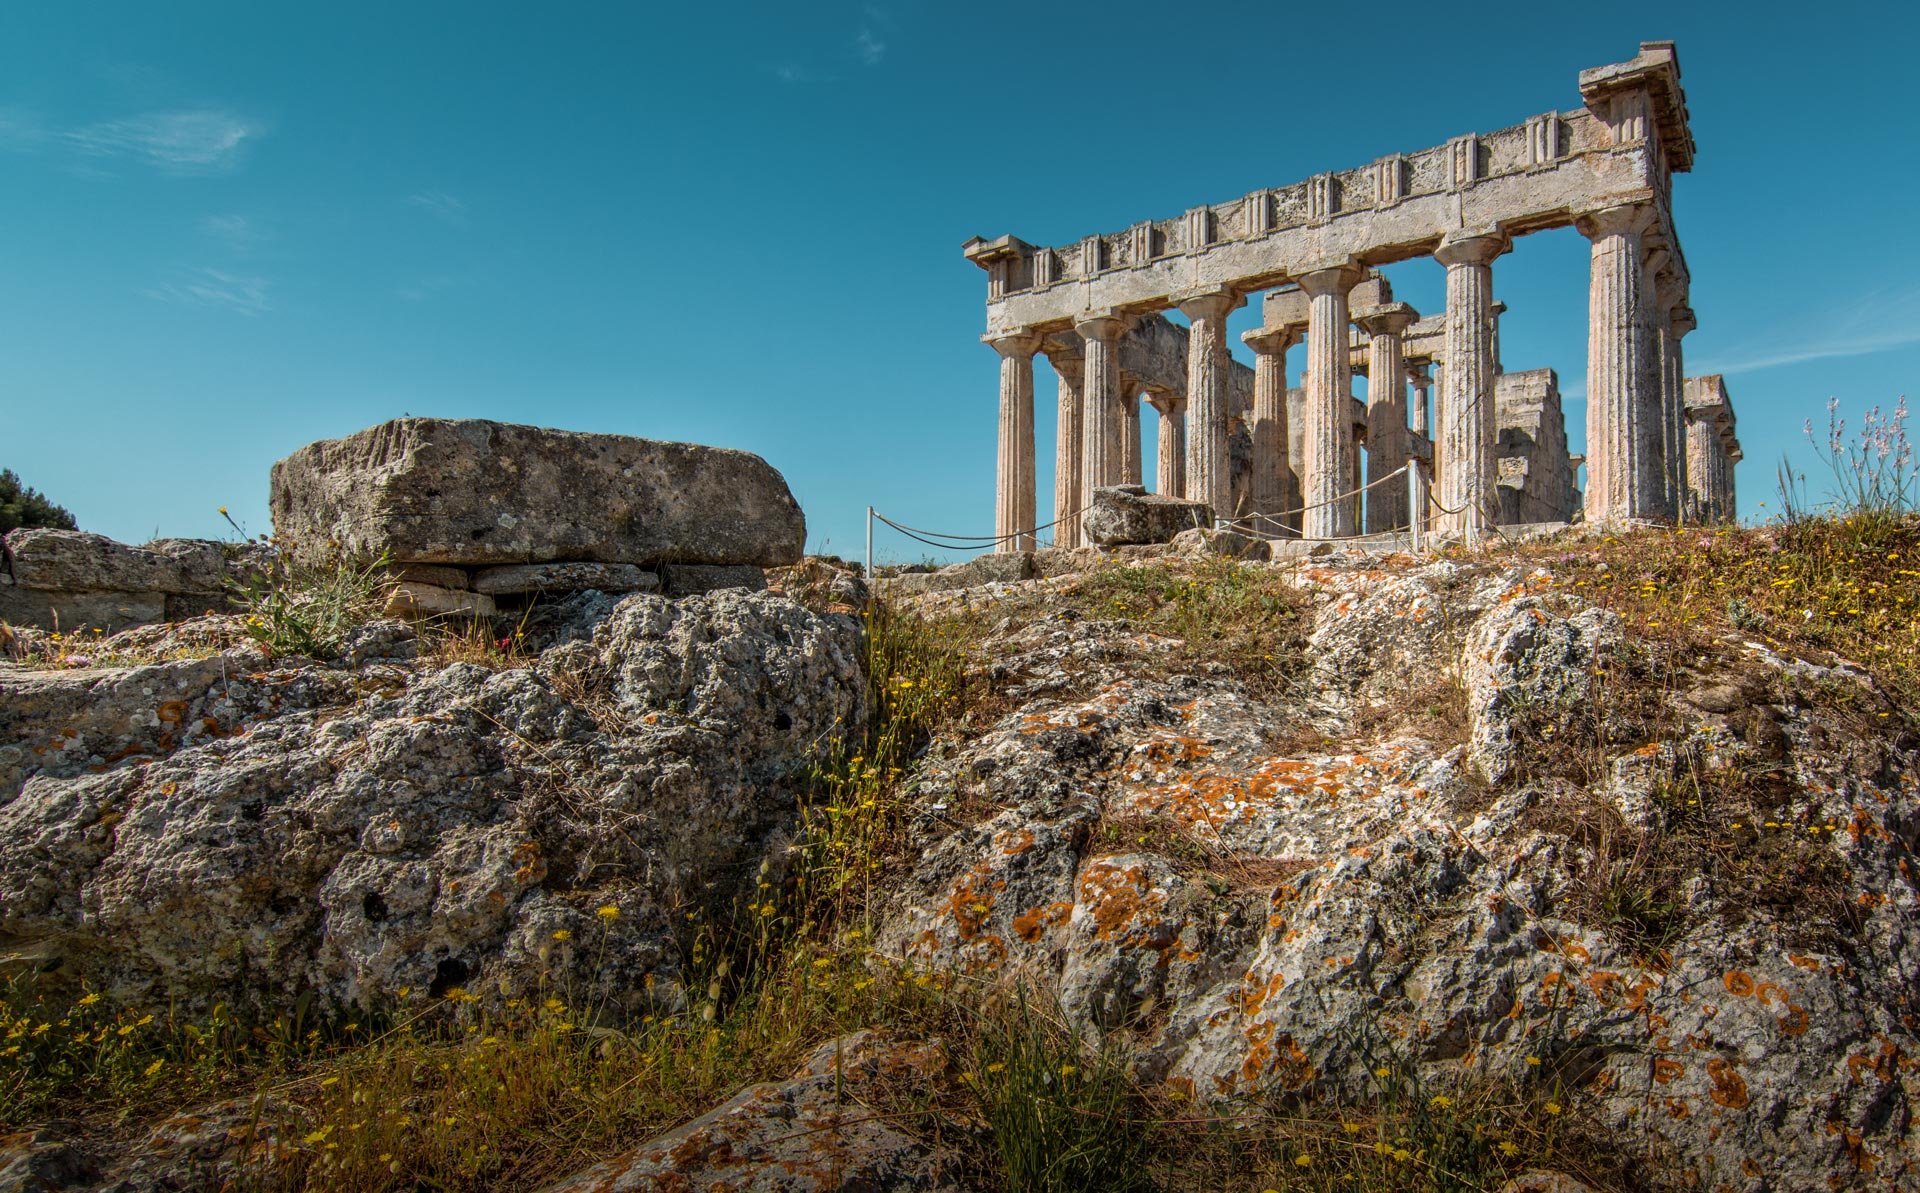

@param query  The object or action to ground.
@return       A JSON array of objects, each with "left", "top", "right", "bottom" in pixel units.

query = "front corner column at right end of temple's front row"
[{"left": 1576, "top": 204, "right": 1663, "bottom": 524}]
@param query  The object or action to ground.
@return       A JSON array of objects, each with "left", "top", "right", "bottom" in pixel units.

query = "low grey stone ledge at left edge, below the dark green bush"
[{"left": 0, "top": 530, "right": 271, "bottom": 630}]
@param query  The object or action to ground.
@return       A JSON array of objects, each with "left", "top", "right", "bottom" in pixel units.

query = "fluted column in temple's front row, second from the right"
[{"left": 1434, "top": 232, "right": 1509, "bottom": 540}]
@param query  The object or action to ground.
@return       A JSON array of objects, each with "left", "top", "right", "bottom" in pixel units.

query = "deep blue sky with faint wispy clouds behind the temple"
[{"left": 0, "top": 0, "right": 1920, "bottom": 559}]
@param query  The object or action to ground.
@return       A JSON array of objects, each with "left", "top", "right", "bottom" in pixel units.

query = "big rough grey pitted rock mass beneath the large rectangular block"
[{"left": 0, "top": 592, "right": 866, "bottom": 1010}]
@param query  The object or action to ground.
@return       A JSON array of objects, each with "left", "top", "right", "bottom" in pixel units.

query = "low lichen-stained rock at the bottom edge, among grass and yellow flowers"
[{"left": 547, "top": 1032, "right": 964, "bottom": 1193}]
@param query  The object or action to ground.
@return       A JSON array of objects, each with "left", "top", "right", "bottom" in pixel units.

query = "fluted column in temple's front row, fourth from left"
[{"left": 1290, "top": 261, "right": 1361, "bottom": 538}]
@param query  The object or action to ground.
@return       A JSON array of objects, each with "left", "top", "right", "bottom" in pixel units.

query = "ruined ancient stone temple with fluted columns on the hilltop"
[{"left": 964, "top": 42, "right": 1740, "bottom": 551}]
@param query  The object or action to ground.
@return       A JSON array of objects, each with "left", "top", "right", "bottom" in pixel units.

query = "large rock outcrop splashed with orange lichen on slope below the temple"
[{"left": 879, "top": 557, "right": 1920, "bottom": 1191}]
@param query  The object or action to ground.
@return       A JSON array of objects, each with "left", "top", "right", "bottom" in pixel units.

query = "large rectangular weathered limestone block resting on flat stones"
[{"left": 273, "top": 419, "right": 806, "bottom": 567}]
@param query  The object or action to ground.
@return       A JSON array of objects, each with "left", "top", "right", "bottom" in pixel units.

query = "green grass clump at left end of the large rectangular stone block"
[{"left": 232, "top": 549, "right": 388, "bottom": 661}]
